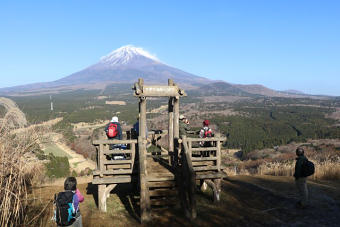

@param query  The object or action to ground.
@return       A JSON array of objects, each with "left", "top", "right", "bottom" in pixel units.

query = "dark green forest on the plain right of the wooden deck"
[{"left": 211, "top": 106, "right": 340, "bottom": 153}]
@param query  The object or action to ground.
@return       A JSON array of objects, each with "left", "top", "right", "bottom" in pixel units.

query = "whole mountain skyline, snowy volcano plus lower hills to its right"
[{"left": 0, "top": 45, "right": 330, "bottom": 97}]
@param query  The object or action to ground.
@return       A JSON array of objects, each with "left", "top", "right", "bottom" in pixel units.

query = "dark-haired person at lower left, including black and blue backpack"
[{"left": 54, "top": 177, "right": 84, "bottom": 227}]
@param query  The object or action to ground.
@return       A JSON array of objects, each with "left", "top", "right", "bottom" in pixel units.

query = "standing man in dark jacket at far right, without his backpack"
[{"left": 294, "top": 147, "right": 308, "bottom": 208}]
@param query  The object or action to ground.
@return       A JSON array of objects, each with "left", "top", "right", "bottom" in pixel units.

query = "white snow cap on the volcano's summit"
[{"left": 100, "top": 45, "right": 159, "bottom": 65}]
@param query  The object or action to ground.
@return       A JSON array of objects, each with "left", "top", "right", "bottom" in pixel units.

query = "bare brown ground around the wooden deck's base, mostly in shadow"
[{"left": 30, "top": 176, "right": 340, "bottom": 226}]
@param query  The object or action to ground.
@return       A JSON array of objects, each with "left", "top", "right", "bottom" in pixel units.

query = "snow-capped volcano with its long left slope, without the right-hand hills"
[{"left": 0, "top": 45, "right": 213, "bottom": 94}]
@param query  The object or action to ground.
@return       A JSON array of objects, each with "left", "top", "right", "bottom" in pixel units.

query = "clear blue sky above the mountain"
[{"left": 0, "top": 0, "right": 340, "bottom": 96}]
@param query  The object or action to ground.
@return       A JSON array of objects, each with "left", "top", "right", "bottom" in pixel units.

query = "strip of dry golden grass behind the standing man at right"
[{"left": 223, "top": 140, "right": 340, "bottom": 181}]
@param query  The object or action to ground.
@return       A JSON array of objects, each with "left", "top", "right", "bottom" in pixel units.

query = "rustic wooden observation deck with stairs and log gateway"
[{"left": 92, "top": 79, "right": 226, "bottom": 222}]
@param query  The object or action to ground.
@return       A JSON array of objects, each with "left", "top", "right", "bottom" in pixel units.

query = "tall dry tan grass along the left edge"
[{"left": 0, "top": 110, "right": 42, "bottom": 226}]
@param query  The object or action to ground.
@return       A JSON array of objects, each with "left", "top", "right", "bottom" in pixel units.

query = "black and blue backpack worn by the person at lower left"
[{"left": 54, "top": 191, "right": 75, "bottom": 226}]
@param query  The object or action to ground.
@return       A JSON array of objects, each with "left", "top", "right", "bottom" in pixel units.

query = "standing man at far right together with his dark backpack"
[{"left": 294, "top": 147, "right": 314, "bottom": 208}]
